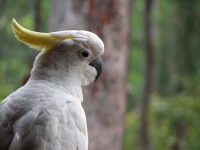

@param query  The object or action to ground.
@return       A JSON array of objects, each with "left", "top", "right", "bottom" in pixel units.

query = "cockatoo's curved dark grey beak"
[{"left": 89, "top": 58, "right": 103, "bottom": 81}]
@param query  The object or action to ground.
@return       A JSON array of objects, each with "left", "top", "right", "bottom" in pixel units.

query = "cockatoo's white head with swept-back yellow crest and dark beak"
[{"left": 12, "top": 19, "right": 104, "bottom": 85}]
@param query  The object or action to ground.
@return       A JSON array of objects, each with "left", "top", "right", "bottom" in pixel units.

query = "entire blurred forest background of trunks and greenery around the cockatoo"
[{"left": 0, "top": 0, "right": 200, "bottom": 150}]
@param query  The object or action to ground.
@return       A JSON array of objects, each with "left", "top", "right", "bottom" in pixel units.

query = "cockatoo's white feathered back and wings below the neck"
[{"left": 0, "top": 85, "right": 87, "bottom": 150}]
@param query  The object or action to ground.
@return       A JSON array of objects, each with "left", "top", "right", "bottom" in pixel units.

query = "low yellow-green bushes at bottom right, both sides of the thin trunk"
[{"left": 123, "top": 93, "right": 200, "bottom": 150}]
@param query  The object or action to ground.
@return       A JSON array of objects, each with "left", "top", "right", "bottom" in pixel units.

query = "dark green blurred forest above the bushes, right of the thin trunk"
[{"left": 155, "top": 0, "right": 200, "bottom": 96}]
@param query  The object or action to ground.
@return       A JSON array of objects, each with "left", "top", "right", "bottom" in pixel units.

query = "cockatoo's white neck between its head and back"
[{"left": 28, "top": 51, "right": 83, "bottom": 101}]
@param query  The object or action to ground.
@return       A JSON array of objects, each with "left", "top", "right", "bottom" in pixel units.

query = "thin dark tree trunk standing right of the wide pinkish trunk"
[{"left": 139, "top": 0, "right": 155, "bottom": 150}]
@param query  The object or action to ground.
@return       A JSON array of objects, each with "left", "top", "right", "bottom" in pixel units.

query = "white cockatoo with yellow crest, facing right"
[{"left": 0, "top": 19, "right": 104, "bottom": 150}]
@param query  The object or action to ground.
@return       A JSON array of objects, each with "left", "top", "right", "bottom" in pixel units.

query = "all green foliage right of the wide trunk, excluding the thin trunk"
[{"left": 126, "top": 0, "right": 200, "bottom": 150}]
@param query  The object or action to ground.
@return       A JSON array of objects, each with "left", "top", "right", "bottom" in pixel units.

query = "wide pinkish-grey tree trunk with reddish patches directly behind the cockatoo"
[{"left": 50, "top": 0, "right": 129, "bottom": 150}]
